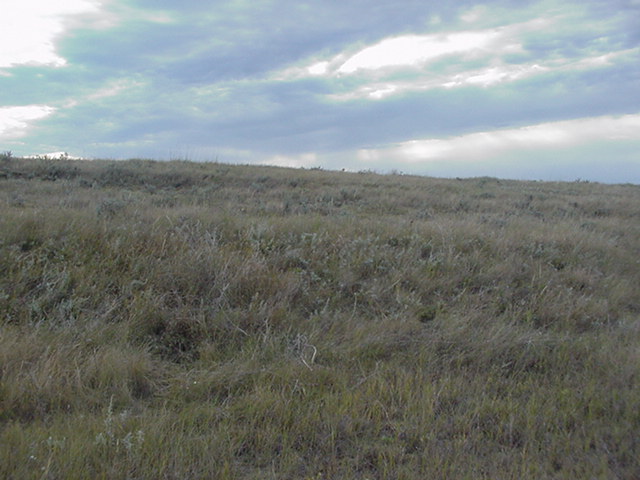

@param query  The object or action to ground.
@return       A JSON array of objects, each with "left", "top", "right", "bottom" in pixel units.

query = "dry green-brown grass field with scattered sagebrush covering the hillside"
[{"left": 0, "top": 157, "right": 640, "bottom": 480}]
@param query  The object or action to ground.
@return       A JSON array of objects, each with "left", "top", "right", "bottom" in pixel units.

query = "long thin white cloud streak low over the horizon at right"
[{"left": 358, "top": 114, "right": 640, "bottom": 163}]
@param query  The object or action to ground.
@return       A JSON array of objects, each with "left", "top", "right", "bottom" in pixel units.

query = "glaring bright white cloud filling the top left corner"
[{"left": 0, "top": 0, "right": 98, "bottom": 68}]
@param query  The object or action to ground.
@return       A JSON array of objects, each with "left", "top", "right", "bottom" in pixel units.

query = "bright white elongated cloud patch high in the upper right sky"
[{"left": 271, "top": 8, "right": 640, "bottom": 102}]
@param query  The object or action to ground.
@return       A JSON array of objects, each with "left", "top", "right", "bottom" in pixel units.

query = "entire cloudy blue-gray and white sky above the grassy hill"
[{"left": 0, "top": 0, "right": 640, "bottom": 183}]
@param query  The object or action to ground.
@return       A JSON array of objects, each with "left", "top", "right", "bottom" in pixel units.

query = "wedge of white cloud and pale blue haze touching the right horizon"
[{"left": 245, "top": 113, "right": 640, "bottom": 183}]
